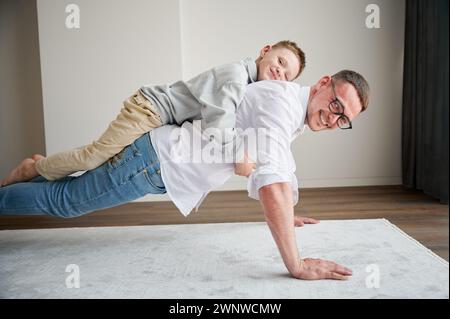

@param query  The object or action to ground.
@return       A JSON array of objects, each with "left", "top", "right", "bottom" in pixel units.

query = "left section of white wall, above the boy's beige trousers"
[{"left": 37, "top": 0, "right": 182, "bottom": 154}]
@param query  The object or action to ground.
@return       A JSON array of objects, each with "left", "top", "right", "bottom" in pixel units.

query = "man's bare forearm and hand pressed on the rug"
[{"left": 259, "top": 183, "right": 352, "bottom": 280}]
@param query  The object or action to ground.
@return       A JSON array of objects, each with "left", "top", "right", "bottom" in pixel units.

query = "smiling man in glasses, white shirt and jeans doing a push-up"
[{"left": 0, "top": 70, "right": 369, "bottom": 280}]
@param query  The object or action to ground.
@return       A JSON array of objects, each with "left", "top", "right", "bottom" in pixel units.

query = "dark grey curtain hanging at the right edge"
[{"left": 402, "top": 0, "right": 449, "bottom": 204}]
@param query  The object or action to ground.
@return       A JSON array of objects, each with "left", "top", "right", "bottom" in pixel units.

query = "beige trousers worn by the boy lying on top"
[{"left": 36, "top": 91, "right": 162, "bottom": 180}]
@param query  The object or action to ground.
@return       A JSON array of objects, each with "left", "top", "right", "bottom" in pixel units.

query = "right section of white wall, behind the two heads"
[{"left": 181, "top": 0, "right": 405, "bottom": 189}]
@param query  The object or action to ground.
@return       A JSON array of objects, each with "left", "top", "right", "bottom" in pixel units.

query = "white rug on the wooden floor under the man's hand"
[{"left": 0, "top": 219, "right": 449, "bottom": 298}]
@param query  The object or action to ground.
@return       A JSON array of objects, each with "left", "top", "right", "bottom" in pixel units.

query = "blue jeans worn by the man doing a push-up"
[{"left": 0, "top": 134, "right": 166, "bottom": 218}]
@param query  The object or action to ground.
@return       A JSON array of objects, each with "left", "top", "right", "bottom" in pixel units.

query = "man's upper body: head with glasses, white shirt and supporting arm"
[{"left": 152, "top": 70, "right": 369, "bottom": 279}]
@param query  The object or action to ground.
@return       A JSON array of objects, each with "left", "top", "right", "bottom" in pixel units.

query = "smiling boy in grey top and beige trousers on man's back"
[{"left": 1, "top": 41, "right": 305, "bottom": 186}]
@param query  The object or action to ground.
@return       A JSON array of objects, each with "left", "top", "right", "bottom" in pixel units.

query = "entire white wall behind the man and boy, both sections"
[{"left": 38, "top": 0, "right": 405, "bottom": 200}]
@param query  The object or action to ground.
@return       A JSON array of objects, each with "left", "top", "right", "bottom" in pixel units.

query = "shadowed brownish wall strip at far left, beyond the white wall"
[{"left": 0, "top": 0, "right": 45, "bottom": 179}]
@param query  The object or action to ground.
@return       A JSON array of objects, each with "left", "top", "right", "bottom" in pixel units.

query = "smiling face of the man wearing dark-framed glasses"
[{"left": 305, "top": 76, "right": 362, "bottom": 131}]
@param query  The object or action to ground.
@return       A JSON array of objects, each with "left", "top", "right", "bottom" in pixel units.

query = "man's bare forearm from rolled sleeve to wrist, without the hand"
[{"left": 259, "top": 183, "right": 301, "bottom": 277}]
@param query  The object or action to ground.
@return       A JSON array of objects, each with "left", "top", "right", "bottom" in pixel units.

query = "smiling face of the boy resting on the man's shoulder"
[{"left": 258, "top": 45, "right": 300, "bottom": 81}]
